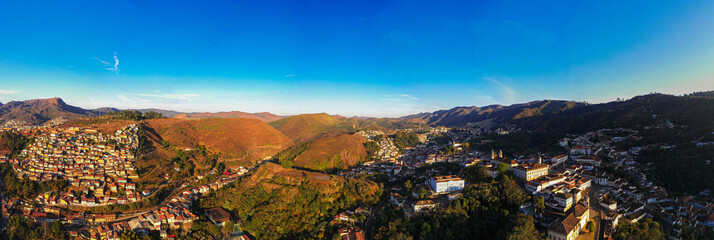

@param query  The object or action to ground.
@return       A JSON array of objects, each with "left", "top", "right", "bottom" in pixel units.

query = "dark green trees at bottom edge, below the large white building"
[{"left": 368, "top": 177, "right": 540, "bottom": 240}]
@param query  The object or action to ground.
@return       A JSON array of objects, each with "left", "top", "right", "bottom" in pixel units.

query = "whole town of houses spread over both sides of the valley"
[{"left": 0, "top": 115, "right": 714, "bottom": 240}]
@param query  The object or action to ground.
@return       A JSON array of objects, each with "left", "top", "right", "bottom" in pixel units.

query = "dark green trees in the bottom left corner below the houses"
[{"left": 0, "top": 216, "right": 69, "bottom": 240}]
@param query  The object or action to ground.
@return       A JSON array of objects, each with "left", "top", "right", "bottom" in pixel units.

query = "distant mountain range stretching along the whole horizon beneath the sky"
[{"left": 5, "top": 91, "right": 714, "bottom": 136}]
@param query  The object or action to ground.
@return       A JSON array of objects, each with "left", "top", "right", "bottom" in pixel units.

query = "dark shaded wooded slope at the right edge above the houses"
[{"left": 638, "top": 144, "right": 714, "bottom": 194}]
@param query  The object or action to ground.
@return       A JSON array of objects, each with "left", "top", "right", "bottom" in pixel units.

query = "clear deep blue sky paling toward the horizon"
[{"left": 0, "top": 1, "right": 714, "bottom": 117}]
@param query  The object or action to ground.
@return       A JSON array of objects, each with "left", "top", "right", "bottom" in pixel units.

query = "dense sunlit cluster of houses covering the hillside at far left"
[{"left": 8, "top": 124, "right": 143, "bottom": 207}]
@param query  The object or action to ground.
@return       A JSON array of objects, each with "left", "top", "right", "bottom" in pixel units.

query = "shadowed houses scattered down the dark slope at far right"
[{"left": 561, "top": 126, "right": 714, "bottom": 239}]
